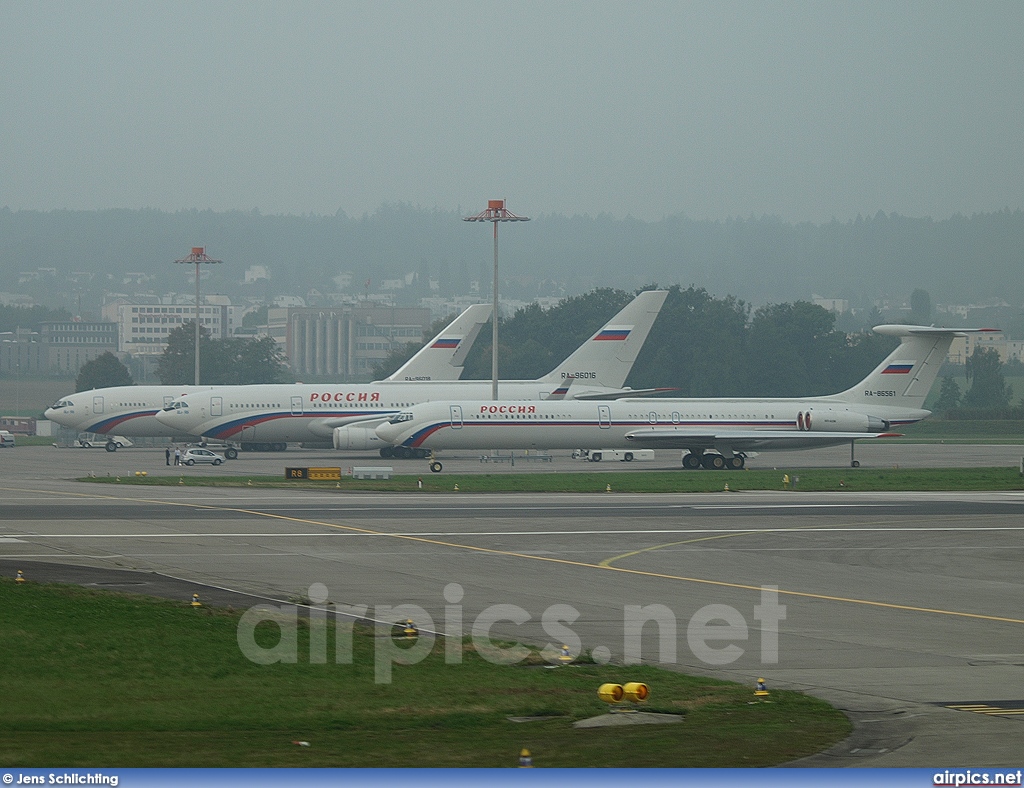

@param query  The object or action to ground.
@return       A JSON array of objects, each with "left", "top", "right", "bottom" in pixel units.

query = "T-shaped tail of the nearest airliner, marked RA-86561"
[{"left": 828, "top": 325, "right": 997, "bottom": 409}]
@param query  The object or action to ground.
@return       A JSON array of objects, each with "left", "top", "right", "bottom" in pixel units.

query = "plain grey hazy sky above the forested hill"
[{"left": 0, "top": 0, "right": 1024, "bottom": 222}]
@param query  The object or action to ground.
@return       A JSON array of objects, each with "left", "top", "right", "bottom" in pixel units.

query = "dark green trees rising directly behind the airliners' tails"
[{"left": 374, "top": 286, "right": 1013, "bottom": 418}]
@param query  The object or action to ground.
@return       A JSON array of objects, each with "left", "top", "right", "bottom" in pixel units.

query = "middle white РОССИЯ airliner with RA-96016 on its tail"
[{"left": 157, "top": 291, "right": 668, "bottom": 458}]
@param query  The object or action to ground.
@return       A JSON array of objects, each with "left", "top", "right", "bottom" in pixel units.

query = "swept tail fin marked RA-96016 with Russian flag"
[{"left": 540, "top": 290, "right": 669, "bottom": 389}]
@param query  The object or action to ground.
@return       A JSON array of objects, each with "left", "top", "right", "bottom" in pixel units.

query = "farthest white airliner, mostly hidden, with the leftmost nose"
[{"left": 45, "top": 304, "right": 490, "bottom": 451}]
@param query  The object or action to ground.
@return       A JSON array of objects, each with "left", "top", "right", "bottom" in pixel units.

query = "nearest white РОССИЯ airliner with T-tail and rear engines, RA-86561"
[{"left": 377, "top": 325, "right": 994, "bottom": 472}]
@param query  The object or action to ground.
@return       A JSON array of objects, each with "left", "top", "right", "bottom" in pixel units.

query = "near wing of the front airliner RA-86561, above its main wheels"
[{"left": 626, "top": 427, "right": 900, "bottom": 451}]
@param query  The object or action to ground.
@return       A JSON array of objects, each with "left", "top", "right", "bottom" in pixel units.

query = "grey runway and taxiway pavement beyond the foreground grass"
[{"left": 0, "top": 446, "right": 1024, "bottom": 768}]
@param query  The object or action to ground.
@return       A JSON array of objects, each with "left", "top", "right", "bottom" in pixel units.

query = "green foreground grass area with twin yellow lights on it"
[{"left": 0, "top": 579, "right": 851, "bottom": 768}]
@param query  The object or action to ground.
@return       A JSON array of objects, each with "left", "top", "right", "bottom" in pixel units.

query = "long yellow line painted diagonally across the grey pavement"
[{"left": 8, "top": 488, "right": 1024, "bottom": 624}]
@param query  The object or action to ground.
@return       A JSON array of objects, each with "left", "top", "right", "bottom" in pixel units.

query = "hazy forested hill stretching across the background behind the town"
[{"left": 0, "top": 205, "right": 1024, "bottom": 307}]
